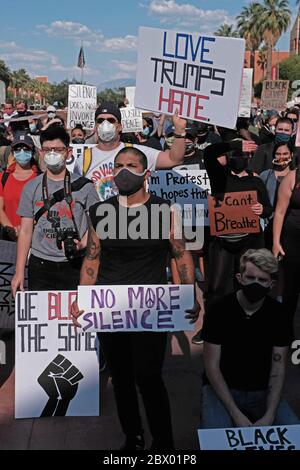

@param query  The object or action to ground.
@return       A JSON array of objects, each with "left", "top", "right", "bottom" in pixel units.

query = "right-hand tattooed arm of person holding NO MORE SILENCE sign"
[{"left": 170, "top": 212, "right": 200, "bottom": 323}]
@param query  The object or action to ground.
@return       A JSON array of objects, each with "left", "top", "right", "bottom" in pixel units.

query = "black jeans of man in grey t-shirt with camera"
[{"left": 28, "top": 255, "right": 82, "bottom": 291}]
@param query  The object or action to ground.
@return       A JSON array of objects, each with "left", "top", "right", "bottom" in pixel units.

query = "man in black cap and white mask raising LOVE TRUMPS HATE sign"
[{"left": 74, "top": 103, "right": 186, "bottom": 201}]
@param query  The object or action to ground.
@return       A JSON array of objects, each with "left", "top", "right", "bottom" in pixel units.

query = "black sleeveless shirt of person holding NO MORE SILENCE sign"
[{"left": 90, "top": 194, "right": 170, "bottom": 285}]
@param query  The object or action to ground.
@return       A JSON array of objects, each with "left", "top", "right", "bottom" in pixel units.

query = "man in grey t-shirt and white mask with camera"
[{"left": 12, "top": 126, "right": 98, "bottom": 295}]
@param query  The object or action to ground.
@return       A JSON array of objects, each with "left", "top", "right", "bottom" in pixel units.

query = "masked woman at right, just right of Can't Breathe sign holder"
[{"left": 259, "top": 143, "right": 293, "bottom": 250}]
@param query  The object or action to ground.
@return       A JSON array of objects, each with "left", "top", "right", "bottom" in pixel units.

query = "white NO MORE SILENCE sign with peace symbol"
[{"left": 78, "top": 285, "right": 194, "bottom": 332}]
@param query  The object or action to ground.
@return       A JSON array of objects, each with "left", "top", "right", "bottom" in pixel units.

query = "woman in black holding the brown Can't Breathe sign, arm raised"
[{"left": 200, "top": 140, "right": 272, "bottom": 314}]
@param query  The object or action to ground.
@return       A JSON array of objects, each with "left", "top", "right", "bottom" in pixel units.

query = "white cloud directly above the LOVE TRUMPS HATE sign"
[{"left": 148, "top": 0, "right": 235, "bottom": 32}]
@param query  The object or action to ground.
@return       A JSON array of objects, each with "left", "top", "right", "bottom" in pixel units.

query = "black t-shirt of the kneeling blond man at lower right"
[{"left": 203, "top": 293, "right": 292, "bottom": 391}]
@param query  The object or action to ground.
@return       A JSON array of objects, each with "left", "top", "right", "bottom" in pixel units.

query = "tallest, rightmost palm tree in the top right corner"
[{"left": 258, "top": 0, "right": 291, "bottom": 80}]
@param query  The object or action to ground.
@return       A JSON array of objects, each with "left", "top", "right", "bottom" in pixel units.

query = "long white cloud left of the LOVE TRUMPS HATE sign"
[{"left": 38, "top": 20, "right": 137, "bottom": 52}]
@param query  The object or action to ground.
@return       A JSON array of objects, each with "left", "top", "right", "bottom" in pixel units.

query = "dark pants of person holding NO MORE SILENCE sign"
[{"left": 98, "top": 332, "right": 174, "bottom": 450}]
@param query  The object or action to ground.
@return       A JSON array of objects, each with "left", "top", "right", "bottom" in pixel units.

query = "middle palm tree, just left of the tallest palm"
[{"left": 236, "top": 2, "right": 263, "bottom": 68}]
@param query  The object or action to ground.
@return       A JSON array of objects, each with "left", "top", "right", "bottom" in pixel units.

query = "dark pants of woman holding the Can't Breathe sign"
[{"left": 206, "top": 233, "right": 264, "bottom": 312}]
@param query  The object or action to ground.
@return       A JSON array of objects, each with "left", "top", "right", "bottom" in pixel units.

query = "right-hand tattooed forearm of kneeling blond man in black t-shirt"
[{"left": 253, "top": 346, "right": 288, "bottom": 426}]
